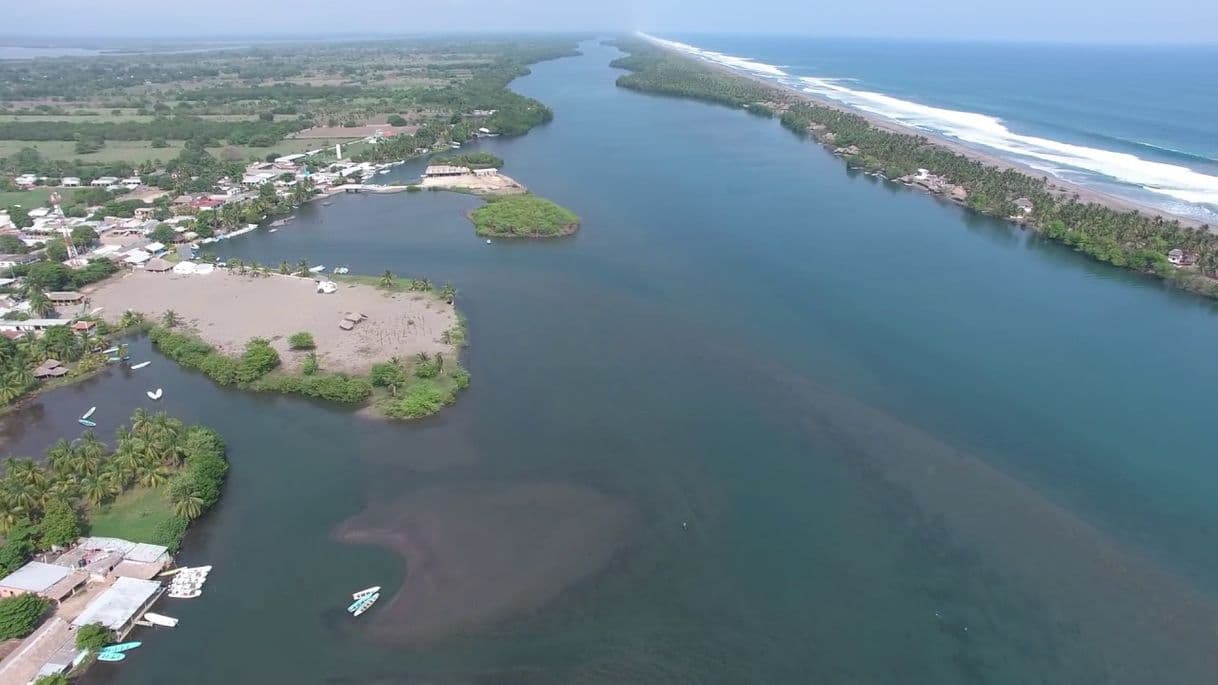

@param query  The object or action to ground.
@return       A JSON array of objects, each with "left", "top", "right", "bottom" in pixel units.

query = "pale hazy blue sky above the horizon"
[{"left": 9, "top": 0, "right": 1218, "bottom": 43}]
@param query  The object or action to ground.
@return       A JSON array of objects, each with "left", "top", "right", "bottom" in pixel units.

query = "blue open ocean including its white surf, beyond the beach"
[{"left": 660, "top": 35, "right": 1218, "bottom": 223}]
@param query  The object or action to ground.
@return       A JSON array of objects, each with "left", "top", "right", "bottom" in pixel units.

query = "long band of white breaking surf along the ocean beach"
[{"left": 644, "top": 34, "right": 1218, "bottom": 216}]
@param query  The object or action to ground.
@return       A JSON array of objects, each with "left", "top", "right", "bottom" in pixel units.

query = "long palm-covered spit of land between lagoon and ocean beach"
[{"left": 613, "top": 38, "right": 1218, "bottom": 297}]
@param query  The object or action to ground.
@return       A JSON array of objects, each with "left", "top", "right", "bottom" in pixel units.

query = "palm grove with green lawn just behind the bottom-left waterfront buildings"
[{"left": 0, "top": 410, "right": 228, "bottom": 565}]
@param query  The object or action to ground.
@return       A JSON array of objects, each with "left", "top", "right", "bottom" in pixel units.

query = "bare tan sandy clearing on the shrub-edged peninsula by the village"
[{"left": 86, "top": 269, "right": 457, "bottom": 373}]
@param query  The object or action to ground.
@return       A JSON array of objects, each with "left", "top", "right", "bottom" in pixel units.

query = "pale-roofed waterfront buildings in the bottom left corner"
[{"left": 0, "top": 538, "right": 173, "bottom": 683}]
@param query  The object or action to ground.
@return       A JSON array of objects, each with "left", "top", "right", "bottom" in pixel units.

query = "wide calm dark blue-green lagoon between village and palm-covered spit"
[{"left": 2, "top": 43, "right": 1218, "bottom": 685}]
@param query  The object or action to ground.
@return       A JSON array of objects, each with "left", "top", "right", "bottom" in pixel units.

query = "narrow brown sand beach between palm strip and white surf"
[{"left": 636, "top": 34, "right": 1218, "bottom": 233}]
